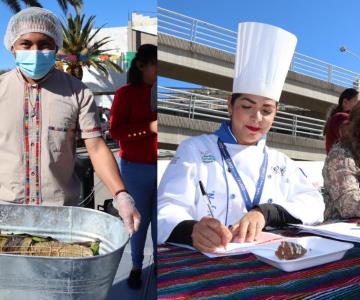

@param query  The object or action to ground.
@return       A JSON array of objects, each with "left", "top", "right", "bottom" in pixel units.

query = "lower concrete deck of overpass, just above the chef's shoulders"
[{"left": 158, "top": 113, "right": 326, "bottom": 161}]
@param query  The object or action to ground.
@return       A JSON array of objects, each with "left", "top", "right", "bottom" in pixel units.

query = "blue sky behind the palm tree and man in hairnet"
[{"left": 0, "top": 0, "right": 157, "bottom": 69}]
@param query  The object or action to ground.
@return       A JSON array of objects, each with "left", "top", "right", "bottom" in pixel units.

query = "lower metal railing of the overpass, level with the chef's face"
[{"left": 158, "top": 86, "right": 325, "bottom": 139}]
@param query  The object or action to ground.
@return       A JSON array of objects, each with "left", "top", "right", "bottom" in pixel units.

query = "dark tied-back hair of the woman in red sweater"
[{"left": 128, "top": 44, "right": 157, "bottom": 84}]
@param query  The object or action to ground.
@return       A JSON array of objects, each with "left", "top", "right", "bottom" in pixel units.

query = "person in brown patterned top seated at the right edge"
[{"left": 323, "top": 103, "right": 360, "bottom": 220}]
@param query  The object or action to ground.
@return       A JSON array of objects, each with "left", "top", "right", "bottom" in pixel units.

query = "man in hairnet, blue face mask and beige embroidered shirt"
[{"left": 0, "top": 7, "right": 140, "bottom": 233}]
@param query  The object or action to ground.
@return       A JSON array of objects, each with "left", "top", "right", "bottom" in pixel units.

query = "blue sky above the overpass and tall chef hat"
[{"left": 158, "top": 0, "right": 360, "bottom": 84}]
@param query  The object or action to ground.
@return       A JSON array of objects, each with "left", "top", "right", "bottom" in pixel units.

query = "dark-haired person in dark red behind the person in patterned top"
[{"left": 324, "top": 88, "right": 359, "bottom": 154}]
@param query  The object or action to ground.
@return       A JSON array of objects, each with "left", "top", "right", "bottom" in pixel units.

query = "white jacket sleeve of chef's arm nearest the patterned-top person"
[{"left": 281, "top": 157, "right": 325, "bottom": 225}]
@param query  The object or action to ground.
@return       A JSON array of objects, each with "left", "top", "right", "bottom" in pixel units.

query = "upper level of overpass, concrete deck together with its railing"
[{"left": 158, "top": 8, "right": 360, "bottom": 119}]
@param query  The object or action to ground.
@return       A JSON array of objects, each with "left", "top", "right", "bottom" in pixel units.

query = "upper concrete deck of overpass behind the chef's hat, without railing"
[{"left": 158, "top": 33, "right": 344, "bottom": 119}]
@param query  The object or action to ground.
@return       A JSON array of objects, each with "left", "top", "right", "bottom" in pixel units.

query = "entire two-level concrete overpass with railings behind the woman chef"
[{"left": 158, "top": 7, "right": 360, "bottom": 160}]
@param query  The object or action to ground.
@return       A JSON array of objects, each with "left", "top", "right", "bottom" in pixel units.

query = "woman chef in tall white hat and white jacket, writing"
[{"left": 158, "top": 22, "right": 324, "bottom": 252}]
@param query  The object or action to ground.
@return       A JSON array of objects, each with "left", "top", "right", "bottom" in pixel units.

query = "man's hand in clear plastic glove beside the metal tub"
[{"left": 113, "top": 191, "right": 140, "bottom": 235}]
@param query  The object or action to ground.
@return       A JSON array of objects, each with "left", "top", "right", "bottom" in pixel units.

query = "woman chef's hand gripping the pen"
[{"left": 191, "top": 217, "right": 232, "bottom": 252}]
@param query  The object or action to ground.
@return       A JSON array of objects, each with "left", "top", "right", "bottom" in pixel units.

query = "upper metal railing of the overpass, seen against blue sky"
[{"left": 158, "top": 7, "right": 360, "bottom": 88}]
